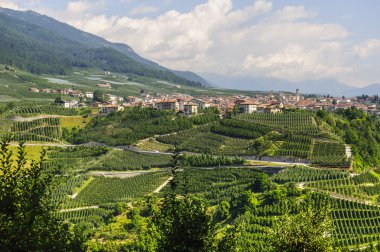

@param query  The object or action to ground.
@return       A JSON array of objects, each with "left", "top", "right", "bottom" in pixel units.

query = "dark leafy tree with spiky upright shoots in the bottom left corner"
[{"left": 0, "top": 142, "right": 82, "bottom": 251}]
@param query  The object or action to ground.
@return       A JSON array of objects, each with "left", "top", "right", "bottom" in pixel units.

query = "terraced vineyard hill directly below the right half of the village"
[{"left": 156, "top": 112, "right": 351, "bottom": 168}]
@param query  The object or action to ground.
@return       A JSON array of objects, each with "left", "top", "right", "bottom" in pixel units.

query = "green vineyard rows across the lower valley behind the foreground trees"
[{"left": 2, "top": 134, "right": 380, "bottom": 251}]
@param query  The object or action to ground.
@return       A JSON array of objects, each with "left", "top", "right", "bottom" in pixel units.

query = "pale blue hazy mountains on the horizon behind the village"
[{"left": 199, "top": 73, "right": 374, "bottom": 96}]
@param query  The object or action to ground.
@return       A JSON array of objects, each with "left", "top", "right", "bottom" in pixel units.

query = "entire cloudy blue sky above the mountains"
[{"left": 0, "top": 0, "right": 380, "bottom": 86}]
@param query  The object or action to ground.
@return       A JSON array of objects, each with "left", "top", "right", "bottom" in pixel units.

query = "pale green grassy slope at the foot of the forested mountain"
[{"left": 0, "top": 65, "right": 280, "bottom": 103}]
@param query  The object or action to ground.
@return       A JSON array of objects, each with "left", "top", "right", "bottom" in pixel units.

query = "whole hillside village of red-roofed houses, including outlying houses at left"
[{"left": 30, "top": 83, "right": 378, "bottom": 115}]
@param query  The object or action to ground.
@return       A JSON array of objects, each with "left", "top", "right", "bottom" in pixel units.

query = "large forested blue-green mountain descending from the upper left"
[{"left": 0, "top": 8, "right": 207, "bottom": 85}]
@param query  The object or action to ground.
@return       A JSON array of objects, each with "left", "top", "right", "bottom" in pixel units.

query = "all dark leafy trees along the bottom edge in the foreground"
[{"left": 0, "top": 142, "right": 331, "bottom": 251}]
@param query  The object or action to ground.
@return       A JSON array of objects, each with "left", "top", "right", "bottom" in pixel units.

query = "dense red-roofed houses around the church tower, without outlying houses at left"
[{"left": 116, "top": 89, "right": 377, "bottom": 115}]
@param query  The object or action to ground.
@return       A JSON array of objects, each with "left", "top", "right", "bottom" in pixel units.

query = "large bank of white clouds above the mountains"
[{"left": 25, "top": 0, "right": 380, "bottom": 85}]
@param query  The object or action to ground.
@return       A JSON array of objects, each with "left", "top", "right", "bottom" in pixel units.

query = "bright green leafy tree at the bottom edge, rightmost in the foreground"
[{"left": 271, "top": 206, "right": 332, "bottom": 252}]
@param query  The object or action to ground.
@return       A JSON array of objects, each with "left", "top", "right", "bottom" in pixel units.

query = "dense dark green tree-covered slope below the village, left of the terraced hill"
[{"left": 63, "top": 107, "right": 218, "bottom": 145}]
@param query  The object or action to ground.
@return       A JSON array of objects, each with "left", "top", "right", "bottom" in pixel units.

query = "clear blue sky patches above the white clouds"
[{"left": 10, "top": 0, "right": 380, "bottom": 39}]
